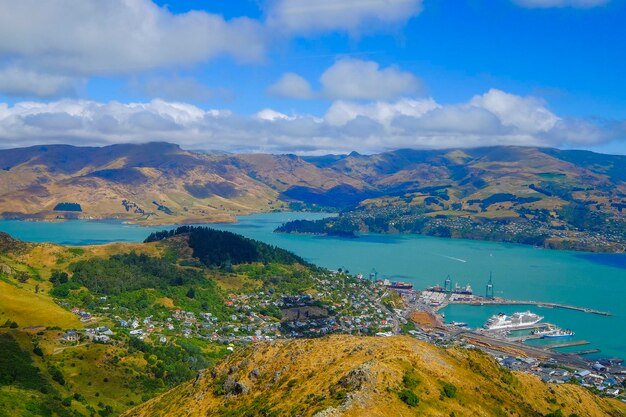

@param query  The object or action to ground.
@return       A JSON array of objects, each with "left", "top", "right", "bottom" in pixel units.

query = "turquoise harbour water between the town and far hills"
[{"left": 0, "top": 213, "right": 626, "bottom": 357}]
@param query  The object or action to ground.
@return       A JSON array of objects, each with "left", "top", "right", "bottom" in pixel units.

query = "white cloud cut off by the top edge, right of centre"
[{"left": 265, "top": 0, "right": 422, "bottom": 35}]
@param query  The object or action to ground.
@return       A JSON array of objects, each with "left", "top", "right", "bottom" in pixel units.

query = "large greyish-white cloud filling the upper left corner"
[{"left": 0, "top": 0, "right": 267, "bottom": 96}]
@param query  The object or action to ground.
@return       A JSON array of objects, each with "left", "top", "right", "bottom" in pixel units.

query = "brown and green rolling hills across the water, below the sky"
[{"left": 0, "top": 143, "right": 626, "bottom": 251}]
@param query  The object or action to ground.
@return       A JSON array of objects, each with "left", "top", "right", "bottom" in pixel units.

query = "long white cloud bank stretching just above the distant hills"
[{"left": 0, "top": 90, "right": 626, "bottom": 154}]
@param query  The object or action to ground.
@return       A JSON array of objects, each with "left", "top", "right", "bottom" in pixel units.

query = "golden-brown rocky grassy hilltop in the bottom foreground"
[{"left": 124, "top": 336, "right": 626, "bottom": 417}]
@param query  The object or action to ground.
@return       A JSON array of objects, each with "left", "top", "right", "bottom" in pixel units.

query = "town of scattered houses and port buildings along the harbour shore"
[{"left": 60, "top": 271, "right": 626, "bottom": 402}]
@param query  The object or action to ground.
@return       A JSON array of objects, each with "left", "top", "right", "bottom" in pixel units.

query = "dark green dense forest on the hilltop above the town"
[{"left": 145, "top": 226, "right": 305, "bottom": 268}]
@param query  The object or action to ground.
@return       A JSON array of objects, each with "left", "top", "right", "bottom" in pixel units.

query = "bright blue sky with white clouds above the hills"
[{"left": 0, "top": 0, "right": 626, "bottom": 154}]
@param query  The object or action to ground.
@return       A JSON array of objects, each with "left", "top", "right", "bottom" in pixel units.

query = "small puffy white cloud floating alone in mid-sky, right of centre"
[{"left": 268, "top": 59, "right": 421, "bottom": 100}]
